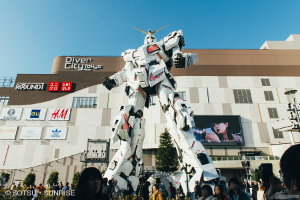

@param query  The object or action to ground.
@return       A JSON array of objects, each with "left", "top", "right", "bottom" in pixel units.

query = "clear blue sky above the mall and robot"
[{"left": 0, "top": 0, "right": 300, "bottom": 77}]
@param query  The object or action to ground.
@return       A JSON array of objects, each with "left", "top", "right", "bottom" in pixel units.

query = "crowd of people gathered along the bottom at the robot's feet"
[{"left": 1, "top": 144, "right": 300, "bottom": 200}]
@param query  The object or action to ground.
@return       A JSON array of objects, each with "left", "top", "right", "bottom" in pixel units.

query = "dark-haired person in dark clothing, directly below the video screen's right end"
[{"left": 227, "top": 178, "right": 250, "bottom": 200}]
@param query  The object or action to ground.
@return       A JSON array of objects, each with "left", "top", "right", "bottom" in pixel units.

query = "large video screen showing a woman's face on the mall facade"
[{"left": 193, "top": 115, "right": 244, "bottom": 145}]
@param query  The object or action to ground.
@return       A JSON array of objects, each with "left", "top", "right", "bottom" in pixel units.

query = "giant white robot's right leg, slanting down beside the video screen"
[{"left": 158, "top": 81, "right": 219, "bottom": 193}]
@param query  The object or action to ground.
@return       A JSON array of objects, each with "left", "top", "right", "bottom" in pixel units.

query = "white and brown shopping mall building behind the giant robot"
[{"left": 0, "top": 34, "right": 300, "bottom": 184}]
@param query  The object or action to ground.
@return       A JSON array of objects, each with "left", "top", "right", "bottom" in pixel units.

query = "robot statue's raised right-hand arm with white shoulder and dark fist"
[{"left": 164, "top": 30, "right": 198, "bottom": 68}]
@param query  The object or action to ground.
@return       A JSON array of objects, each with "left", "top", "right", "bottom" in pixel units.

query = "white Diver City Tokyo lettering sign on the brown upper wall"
[{"left": 65, "top": 57, "right": 103, "bottom": 71}]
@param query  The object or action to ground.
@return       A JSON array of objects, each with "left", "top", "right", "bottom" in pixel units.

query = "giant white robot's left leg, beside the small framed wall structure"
[{"left": 104, "top": 86, "right": 145, "bottom": 190}]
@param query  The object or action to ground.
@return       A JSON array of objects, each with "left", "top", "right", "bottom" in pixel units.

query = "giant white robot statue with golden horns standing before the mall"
[{"left": 103, "top": 27, "right": 218, "bottom": 193}]
